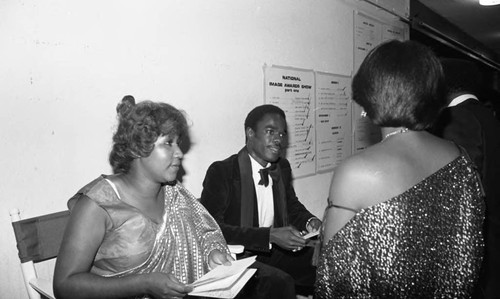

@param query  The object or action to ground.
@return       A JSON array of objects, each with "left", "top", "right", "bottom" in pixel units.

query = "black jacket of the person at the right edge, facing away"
[{"left": 432, "top": 99, "right": 500, "bottom": 298}]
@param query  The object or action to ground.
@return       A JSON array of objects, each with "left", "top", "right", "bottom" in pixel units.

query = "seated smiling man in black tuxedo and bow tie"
[{"left": 201, "top": 105, "right": 321, "bottom": 298}]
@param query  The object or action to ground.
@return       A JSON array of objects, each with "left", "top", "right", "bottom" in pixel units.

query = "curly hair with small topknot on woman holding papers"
[{"left": 109, "top": 95, "right": 187, "bottom": 173}]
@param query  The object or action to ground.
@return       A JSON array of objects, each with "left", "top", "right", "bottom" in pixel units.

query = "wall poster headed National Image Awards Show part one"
[{"left": 264, "top": 65, "right": 316, "bottom": 178}]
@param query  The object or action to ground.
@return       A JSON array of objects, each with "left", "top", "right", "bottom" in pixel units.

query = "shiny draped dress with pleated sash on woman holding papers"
[{"left": 72, "top": 178, "right": 229, "bottom": 283}]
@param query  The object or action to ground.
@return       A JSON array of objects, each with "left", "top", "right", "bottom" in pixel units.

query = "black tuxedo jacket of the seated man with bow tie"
[{"left": 200, "top": 148, "right": 314, "bottom": 252}]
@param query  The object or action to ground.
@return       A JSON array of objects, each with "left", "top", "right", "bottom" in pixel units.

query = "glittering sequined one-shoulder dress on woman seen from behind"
[{"left": 315, "top": 156, "right": 484, "bottom": 298}]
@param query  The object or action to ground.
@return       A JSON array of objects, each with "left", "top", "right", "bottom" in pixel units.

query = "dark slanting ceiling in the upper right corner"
[{"left": 411, "top": 0, "right": 500, "bottom": 69}]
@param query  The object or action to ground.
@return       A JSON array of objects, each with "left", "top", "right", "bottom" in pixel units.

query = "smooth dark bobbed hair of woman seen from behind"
[{"left": 352, "top": 40, "right": 446, "bottom": 131}]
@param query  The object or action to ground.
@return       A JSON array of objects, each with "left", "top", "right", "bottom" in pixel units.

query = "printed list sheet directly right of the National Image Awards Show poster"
[{"left": 316, "top": 72, "right": 352, "bottom": 172}]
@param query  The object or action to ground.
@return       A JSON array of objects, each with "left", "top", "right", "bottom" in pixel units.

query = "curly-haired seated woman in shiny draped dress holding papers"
[{"left": 54, "top": 96, "right": 231, "bottom": 298}]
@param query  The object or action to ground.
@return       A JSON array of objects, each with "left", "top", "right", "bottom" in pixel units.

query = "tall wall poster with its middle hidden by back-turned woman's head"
[{"left": 352, "top": 11, "right": 382, "bottom": 153}]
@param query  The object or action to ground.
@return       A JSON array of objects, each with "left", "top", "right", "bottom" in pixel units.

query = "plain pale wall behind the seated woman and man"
[{"left": 0, "top": 0, "right": 406, "bottom": 298}]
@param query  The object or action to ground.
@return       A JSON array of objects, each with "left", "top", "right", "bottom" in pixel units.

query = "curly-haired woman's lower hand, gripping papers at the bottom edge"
[{"left": 144, "top": 272, "right": 193, "bottom": 298}]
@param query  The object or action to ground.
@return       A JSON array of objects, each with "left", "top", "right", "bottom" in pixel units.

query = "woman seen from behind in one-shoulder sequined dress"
[{"left": 315, "top": 41, "right": 484, "bottom": 298}]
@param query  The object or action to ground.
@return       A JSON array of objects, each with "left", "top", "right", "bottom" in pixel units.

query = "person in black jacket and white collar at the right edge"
[{"left": 433, "top": 59, "right": 500, "bottom": 298}]
